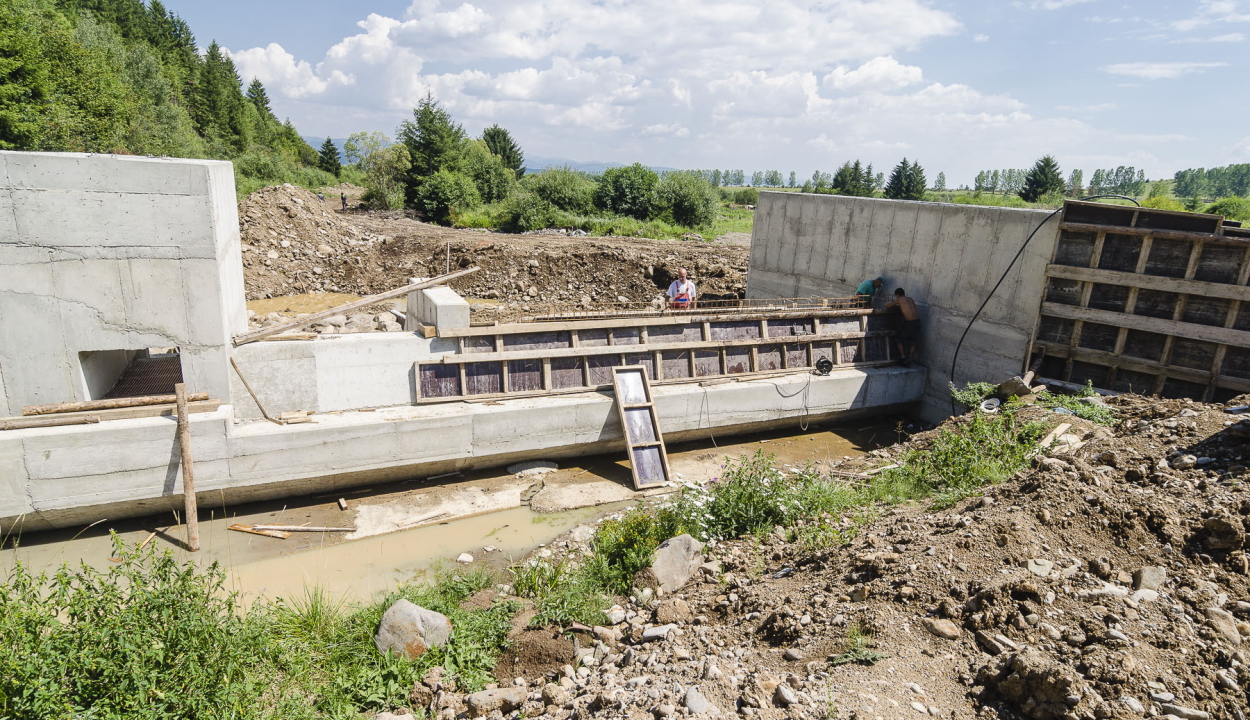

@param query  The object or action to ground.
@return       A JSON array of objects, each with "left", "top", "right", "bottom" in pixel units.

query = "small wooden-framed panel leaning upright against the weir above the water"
[{"left": 613, "top": 365, "right": 673, "bottom": 490}]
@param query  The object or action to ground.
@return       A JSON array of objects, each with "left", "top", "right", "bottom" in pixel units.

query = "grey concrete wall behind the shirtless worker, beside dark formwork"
[{"left": 746, "top": 193, "right": 1059, "bottom": 420}]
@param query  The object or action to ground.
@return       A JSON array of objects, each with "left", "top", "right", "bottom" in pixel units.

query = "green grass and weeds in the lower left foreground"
[{"left": 0, "top": 543, "right": 519, "bottom": 720}]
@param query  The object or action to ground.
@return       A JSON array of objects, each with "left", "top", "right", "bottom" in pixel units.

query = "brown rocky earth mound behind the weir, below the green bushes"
[{"left": 239, "top": 185, "right": 749, "bottom": 313}]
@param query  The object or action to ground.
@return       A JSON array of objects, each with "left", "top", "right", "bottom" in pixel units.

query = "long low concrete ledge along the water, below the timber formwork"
[{"left": 0, "top": 365, "right": 925, "bottom": 531}]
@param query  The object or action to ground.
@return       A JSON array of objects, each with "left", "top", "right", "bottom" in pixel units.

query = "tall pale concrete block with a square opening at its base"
[{"left": 0, "top": 153, "right": 248, "bottom": 415}]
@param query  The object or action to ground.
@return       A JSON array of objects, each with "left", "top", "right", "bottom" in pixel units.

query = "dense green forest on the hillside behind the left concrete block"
[{"left": 0, "top": 0, "right": 336, "bottom": 195}]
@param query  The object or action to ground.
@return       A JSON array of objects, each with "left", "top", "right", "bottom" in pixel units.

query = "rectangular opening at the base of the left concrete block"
[{"left": 79, "top": 348, "right": 183, "bottom": 400}]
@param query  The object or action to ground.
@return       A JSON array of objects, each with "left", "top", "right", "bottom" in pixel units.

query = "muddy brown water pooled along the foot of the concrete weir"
[{"left": 0, "top": 420, "right": 896, "bottom": 603}]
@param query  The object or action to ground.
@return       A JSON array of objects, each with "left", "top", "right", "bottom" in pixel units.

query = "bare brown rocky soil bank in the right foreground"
[{"left": 384, "top": 396, "right": 1250, "bottom": 720}]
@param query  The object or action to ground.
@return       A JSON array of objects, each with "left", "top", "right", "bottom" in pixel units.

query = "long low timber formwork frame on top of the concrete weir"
[{"left": 414, "top": 306, "right": 898, "bottom": 404}]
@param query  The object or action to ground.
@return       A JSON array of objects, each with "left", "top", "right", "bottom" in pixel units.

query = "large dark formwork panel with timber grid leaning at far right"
[{"left": 1029, "top": 201, "right": 1250, "bottom": 401}]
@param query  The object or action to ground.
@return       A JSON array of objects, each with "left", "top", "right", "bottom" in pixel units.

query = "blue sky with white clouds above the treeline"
[{"left": 168, "top": 0, "right": 1250, "bottom": 186}]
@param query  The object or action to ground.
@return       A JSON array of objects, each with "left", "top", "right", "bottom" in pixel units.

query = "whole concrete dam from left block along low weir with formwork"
[{"left": 0, "top": 153, "right": 926, "bottom": 531}]
